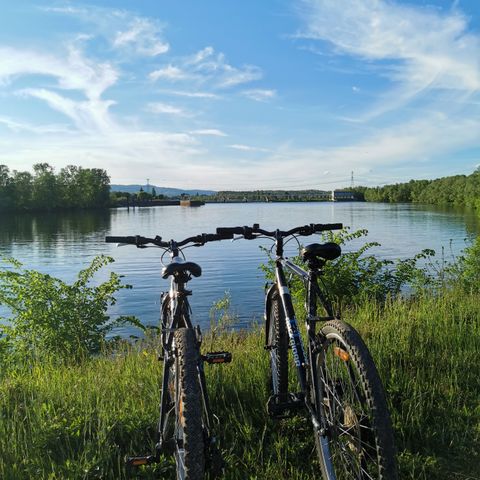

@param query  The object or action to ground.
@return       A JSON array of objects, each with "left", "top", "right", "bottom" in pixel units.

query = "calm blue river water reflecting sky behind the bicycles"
[{"left": 0, "top": 202, "right": 480, "bottom": 335}]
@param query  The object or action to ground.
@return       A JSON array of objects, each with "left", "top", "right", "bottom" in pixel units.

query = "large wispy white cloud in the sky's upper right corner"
[{"left": 301, "top": 0, "right": 480, "bottom": 114}]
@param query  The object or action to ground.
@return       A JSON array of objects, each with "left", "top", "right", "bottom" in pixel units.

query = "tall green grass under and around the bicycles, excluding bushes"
[{"left": 0, "top": 291, "right": 480, "bottom": 480}]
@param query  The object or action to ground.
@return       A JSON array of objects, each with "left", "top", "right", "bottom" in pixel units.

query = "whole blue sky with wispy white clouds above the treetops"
[{"left": 0, "top": 0, "right": 480, "bottom": 190}]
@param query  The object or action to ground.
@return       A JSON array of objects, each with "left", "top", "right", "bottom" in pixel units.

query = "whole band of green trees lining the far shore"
[{"left": 0, "top": 163, "right": 480, "bottom": 211}]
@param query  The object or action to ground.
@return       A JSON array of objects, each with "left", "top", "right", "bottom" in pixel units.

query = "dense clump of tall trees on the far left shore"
[{"left": 0, "top": 163, "right": 110, "bottom": 211}]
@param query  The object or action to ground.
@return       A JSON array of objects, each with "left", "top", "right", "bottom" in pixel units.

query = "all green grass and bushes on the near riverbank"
[{"left": 0, "top": 231, "right": 480, "bottom": 480}]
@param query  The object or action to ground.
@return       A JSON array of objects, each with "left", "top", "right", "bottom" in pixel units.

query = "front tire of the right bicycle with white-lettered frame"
[{"left": 268, "top": 290, "right": 289, "bottom": 402}]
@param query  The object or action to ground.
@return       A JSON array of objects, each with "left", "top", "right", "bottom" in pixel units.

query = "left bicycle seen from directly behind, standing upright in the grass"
[{"left": 105, "top": 233, "right": 233, "bottom": 480}]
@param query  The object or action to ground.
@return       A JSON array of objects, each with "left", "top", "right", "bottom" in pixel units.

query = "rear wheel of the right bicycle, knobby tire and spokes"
[{"left": 312, "top": 320, "right": 398, "bottom": 480}]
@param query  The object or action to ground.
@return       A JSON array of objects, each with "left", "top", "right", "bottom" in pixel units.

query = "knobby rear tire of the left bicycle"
[{"left": 173, "top": 328, "right": 205, "bottom": 480}]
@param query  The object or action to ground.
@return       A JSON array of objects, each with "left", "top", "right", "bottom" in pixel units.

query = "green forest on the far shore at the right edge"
[{"left": 353, "top": 168, "right": 480, "bottom": 210}]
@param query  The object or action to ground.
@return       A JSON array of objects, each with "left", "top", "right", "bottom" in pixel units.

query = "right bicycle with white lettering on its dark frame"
[{"left": 217, "top": 224, "right": 397, "bottom": 480}]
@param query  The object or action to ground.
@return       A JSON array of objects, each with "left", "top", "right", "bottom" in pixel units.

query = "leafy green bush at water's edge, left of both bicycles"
[{"left": 0, "top": 255, "right": 140, "bottom": 361}]
